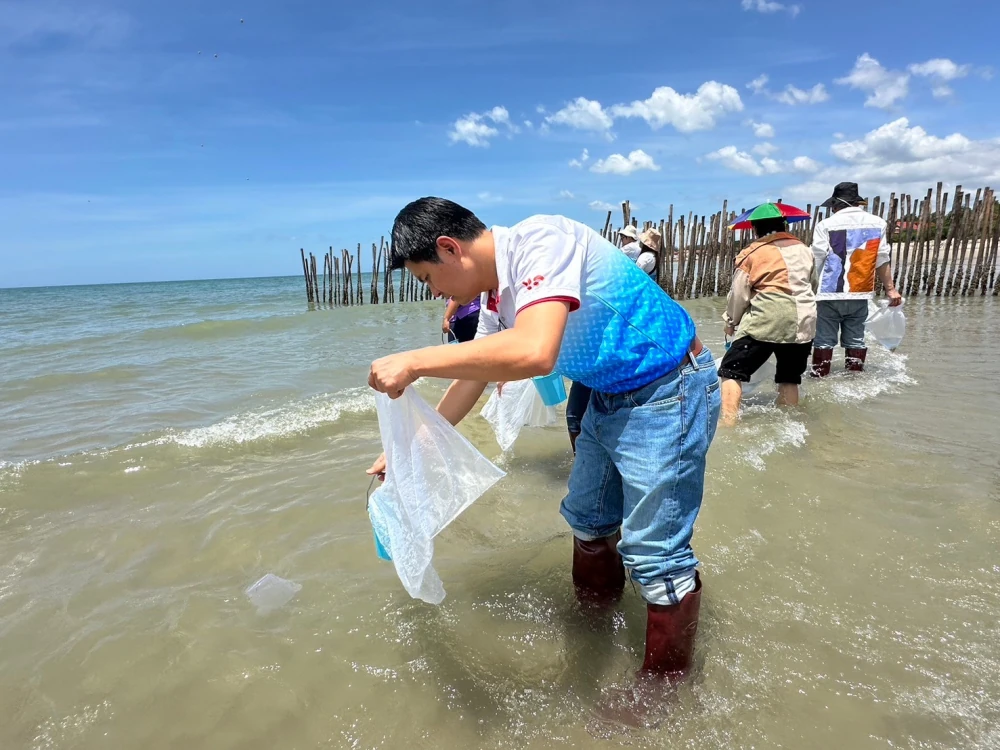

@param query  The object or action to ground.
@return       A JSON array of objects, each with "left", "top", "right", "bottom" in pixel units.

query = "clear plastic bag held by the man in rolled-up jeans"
[{"left": 368, "top": 388, "right": 504, "bottom": 604}]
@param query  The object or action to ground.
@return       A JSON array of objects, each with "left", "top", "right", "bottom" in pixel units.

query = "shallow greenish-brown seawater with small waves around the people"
[{"left": 0, "top": 279, "right": 1000, "bottom": 749}]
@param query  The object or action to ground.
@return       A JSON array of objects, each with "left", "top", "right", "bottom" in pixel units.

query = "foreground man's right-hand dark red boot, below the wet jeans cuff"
[{"left": 642, "top": 573, "right": 701, "bottom": 684}]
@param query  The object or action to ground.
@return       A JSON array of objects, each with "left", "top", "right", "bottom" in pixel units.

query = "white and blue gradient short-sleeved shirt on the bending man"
[{"left": 476, "top": 216, "right": 695, "bottom": 393}]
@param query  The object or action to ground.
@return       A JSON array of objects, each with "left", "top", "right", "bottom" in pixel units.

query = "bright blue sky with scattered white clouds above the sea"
[{"left": 0, "top": 0, "right": 1000, "bottom": 287}]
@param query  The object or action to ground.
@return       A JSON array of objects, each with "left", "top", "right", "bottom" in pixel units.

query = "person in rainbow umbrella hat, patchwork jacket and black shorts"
[{"left": 719, "top": 202, "right": 819, "bottom": 426}]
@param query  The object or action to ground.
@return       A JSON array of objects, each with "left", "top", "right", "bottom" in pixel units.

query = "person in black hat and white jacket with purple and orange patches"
[{"left": 809, "top": 182, "right": 903, "bottom": 378}]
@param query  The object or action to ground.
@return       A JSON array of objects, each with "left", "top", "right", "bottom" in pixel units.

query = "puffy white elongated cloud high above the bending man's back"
[{"left": 611, "top": 81, "right": 743, "bottom": 133}]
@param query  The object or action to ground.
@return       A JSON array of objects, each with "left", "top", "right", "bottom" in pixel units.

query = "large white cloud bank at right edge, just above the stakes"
[{"left": 789, "top": 117, "right": 1000, "bottom": 200}]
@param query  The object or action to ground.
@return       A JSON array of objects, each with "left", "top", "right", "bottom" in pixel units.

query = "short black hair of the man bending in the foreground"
[{"left": 389, "top": 198, "right": 486, "bottom": 271}]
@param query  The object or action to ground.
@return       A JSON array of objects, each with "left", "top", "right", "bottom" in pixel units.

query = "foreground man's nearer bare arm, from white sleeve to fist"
[{"left": 368, "top": 300, "right": 570, "bottom": 400}]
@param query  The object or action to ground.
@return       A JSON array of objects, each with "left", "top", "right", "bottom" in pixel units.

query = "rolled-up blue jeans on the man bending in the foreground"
[{"left": 561, "top": 348, "right": 721, "bottom": 604}]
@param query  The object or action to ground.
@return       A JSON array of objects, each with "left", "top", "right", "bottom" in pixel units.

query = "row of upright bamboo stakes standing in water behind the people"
[{"left": 300, "top": 182, "right": 1000, "bottom": 307}]
